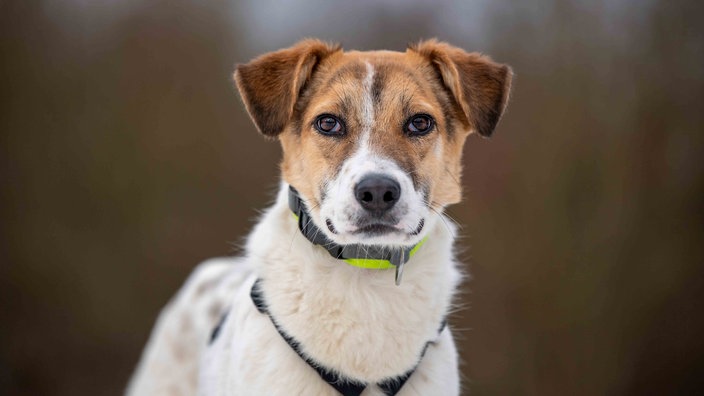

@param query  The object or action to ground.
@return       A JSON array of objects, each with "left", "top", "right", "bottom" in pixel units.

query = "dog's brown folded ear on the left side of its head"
[{"left": 235, "top": 39, "right": 341, "bottom": 137}]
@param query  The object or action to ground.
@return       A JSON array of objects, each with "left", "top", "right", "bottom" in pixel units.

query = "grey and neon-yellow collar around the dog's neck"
[{"left": 288, "top": 186, "right": 428, "bottom": 285}]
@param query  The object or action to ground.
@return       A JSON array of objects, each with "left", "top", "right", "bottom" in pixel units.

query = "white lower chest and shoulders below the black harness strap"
[{"left": 199, "top": 293, "right": 458, "bottom": 396}]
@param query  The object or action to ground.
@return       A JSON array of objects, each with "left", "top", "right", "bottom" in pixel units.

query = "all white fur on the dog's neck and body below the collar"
[{"left": 127, "top": 184, "right": 460, "bottom": 396}]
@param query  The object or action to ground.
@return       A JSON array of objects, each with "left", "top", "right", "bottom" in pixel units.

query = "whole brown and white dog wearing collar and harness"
[{"left": 127, "top": 39, "right": 512, "bottom": 396}]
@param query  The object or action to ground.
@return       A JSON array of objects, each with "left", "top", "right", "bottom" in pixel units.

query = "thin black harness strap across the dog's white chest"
[{"left": 250, "top": 279, "right": 447, "bottom": 396}]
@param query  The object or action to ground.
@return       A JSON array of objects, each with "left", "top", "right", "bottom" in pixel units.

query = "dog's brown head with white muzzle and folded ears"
[{"left": 235, "top": 40, "right": 511, "bottom": 246}]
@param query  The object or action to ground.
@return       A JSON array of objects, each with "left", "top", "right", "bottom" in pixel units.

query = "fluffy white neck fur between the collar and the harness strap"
[{"left": 247, "top": 183, "right": 461, "bottom": 382}]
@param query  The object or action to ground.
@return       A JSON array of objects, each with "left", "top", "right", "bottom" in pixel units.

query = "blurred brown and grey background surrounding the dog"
[{"left": 0, "top": 0, "right": 704, "bottom": 396}]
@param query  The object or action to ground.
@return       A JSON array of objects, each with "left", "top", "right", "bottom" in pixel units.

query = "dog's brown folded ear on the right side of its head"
[{"left": 409, "top": 40, "right": 513, "bottom": 137}]
